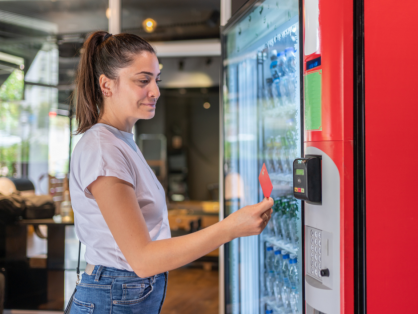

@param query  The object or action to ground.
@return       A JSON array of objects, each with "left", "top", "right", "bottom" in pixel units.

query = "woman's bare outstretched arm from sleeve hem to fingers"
[{"left": 89, "top": 177, "right": 273, "bottom": 278}]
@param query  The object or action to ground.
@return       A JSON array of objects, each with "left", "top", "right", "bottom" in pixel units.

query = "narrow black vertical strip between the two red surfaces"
[{"left": 353, "top": 0, "right": 367, "bottom": 314}]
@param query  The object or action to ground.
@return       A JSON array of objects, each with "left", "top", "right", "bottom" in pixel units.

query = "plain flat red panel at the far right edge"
[{"left": 364, "top": 0, "right": 418, "bottom": 313}]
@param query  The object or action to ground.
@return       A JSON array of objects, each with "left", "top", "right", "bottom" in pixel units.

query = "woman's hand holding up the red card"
[{"left": 224, "top": 197, "right": 274, "bottom": 240}]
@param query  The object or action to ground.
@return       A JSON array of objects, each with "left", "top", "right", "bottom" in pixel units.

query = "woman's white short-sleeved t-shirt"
[{"left": 70, "top": 123, "right": 171, "bottom": 271}]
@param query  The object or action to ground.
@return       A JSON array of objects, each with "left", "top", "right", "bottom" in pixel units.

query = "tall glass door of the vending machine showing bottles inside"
[{"left": 223, "top": 0, "right": 302, "bottom": 314}]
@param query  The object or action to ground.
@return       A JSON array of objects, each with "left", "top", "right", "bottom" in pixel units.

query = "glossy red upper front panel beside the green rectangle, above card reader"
[{"left": 304, "top": 0, "right": 353, "bottom": 141}]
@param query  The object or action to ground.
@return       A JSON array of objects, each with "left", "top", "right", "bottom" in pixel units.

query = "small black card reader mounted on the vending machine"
[{"left": 293, "top": 155, "right": 322, "bottom": 205}]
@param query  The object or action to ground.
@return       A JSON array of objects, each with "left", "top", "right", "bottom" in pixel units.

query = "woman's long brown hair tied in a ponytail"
[{"left": 74, "top": 31, "right": 155, "bottom": 134}]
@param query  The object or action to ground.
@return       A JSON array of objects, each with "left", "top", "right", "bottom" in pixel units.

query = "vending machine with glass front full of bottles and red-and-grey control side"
[{"left": 221, "top": 0, "right": 354, "bottom": 314}]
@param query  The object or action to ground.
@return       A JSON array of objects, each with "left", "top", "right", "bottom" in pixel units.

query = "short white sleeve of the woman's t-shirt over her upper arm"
[{"left": 79, "top": 143, "right": 135, "bottom": 199}]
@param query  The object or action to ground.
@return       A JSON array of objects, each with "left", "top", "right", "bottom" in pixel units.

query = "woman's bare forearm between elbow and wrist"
[{"left": 131, "top": 220, "right": 232, "bottom": 277}]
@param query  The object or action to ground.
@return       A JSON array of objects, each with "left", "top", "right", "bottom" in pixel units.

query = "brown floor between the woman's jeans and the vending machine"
[{"left": 161, "top": 268, "right": 219, "bottom": 314}]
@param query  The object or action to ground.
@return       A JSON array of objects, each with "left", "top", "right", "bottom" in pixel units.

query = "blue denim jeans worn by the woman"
[{"left": 71, "top": 266, "right": 168, "bottom": 314}]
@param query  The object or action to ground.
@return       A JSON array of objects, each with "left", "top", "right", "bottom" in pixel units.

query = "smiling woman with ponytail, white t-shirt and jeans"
[{"left": 70, "top": 32, "right": 273, "bottom": 314}]
